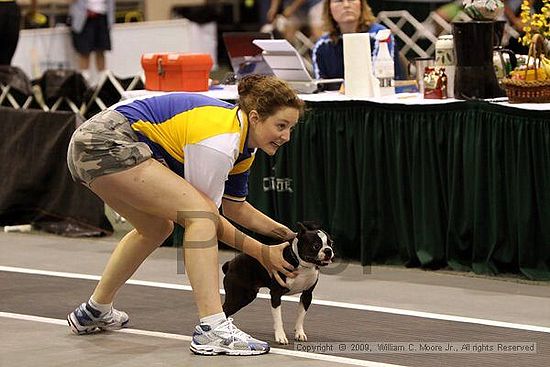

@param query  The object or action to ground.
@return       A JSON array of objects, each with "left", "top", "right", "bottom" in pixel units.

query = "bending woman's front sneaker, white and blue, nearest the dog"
[{"left": 189, "top": 318, "right": 269, "bottom": 356}]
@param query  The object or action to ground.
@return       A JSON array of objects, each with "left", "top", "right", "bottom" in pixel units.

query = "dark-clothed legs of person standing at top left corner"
[{"left": 0, "top": 2, "right": 21, "bottom": 65}]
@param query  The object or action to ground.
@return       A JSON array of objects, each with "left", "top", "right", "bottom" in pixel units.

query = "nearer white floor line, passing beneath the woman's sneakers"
[{"left": 0, "top": 312, "right": 405, "bottom": 367}]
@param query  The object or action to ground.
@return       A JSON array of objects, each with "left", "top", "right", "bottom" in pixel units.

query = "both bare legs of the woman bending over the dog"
[{"left": 91, "top": 159, "right": 222, "bottom": 317}]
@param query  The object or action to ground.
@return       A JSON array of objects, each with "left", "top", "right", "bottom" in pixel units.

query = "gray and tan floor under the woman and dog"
[{"left": 0, "top": 233, "right": 550, "bottom": 366}]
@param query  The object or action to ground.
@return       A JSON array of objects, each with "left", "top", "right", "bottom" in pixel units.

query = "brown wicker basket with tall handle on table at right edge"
[{"left": 502, "top": 34, "right": 550, "bottom": 103}]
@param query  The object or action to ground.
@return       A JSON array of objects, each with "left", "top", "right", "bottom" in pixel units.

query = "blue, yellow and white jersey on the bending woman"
[{"left": 113, "top": 93, "right": 256, "bottom": 206}]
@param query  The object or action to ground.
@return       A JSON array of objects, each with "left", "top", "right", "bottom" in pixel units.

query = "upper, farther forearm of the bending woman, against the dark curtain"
[{"left": 222, "top": 199, "right": 296, "bottom": 241}]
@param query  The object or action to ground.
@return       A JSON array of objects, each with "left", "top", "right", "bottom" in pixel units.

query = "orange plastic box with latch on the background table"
[{"left": 141, "top": 52, "right": 214, "bottom": 92}]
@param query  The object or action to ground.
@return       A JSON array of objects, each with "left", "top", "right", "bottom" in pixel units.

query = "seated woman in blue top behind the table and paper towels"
[{"left": 312, "top": 0, "right": 401, "bottom": 90}]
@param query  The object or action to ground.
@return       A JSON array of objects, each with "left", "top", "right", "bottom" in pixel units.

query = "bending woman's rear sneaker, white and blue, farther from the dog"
[{"left": 67, "top": 303, "right": 128, "bottom": 335}]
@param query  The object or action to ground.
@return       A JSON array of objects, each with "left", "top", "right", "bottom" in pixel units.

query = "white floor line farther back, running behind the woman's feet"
[{"left": 0, "top": 266, "right": 550, "bottom": 333}]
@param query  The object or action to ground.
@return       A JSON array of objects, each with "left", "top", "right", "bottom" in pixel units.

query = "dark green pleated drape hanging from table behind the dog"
[{"left": 249, "top": 101, "right": 550, "bottom": 279}]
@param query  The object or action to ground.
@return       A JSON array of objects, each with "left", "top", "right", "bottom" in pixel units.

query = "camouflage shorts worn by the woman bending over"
[{"left": 67, "top": 110, "right": 153, "bottom": 186}]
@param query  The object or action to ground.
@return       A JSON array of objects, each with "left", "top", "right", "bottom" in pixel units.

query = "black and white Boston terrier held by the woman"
[{"left": 222, "top": 223, "right": 334, "bottom": 344}]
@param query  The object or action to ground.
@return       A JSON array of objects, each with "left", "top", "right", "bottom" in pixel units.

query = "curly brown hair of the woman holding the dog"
[{"left": 237, "top": 75, "right": 304, "bottom": 120}]
